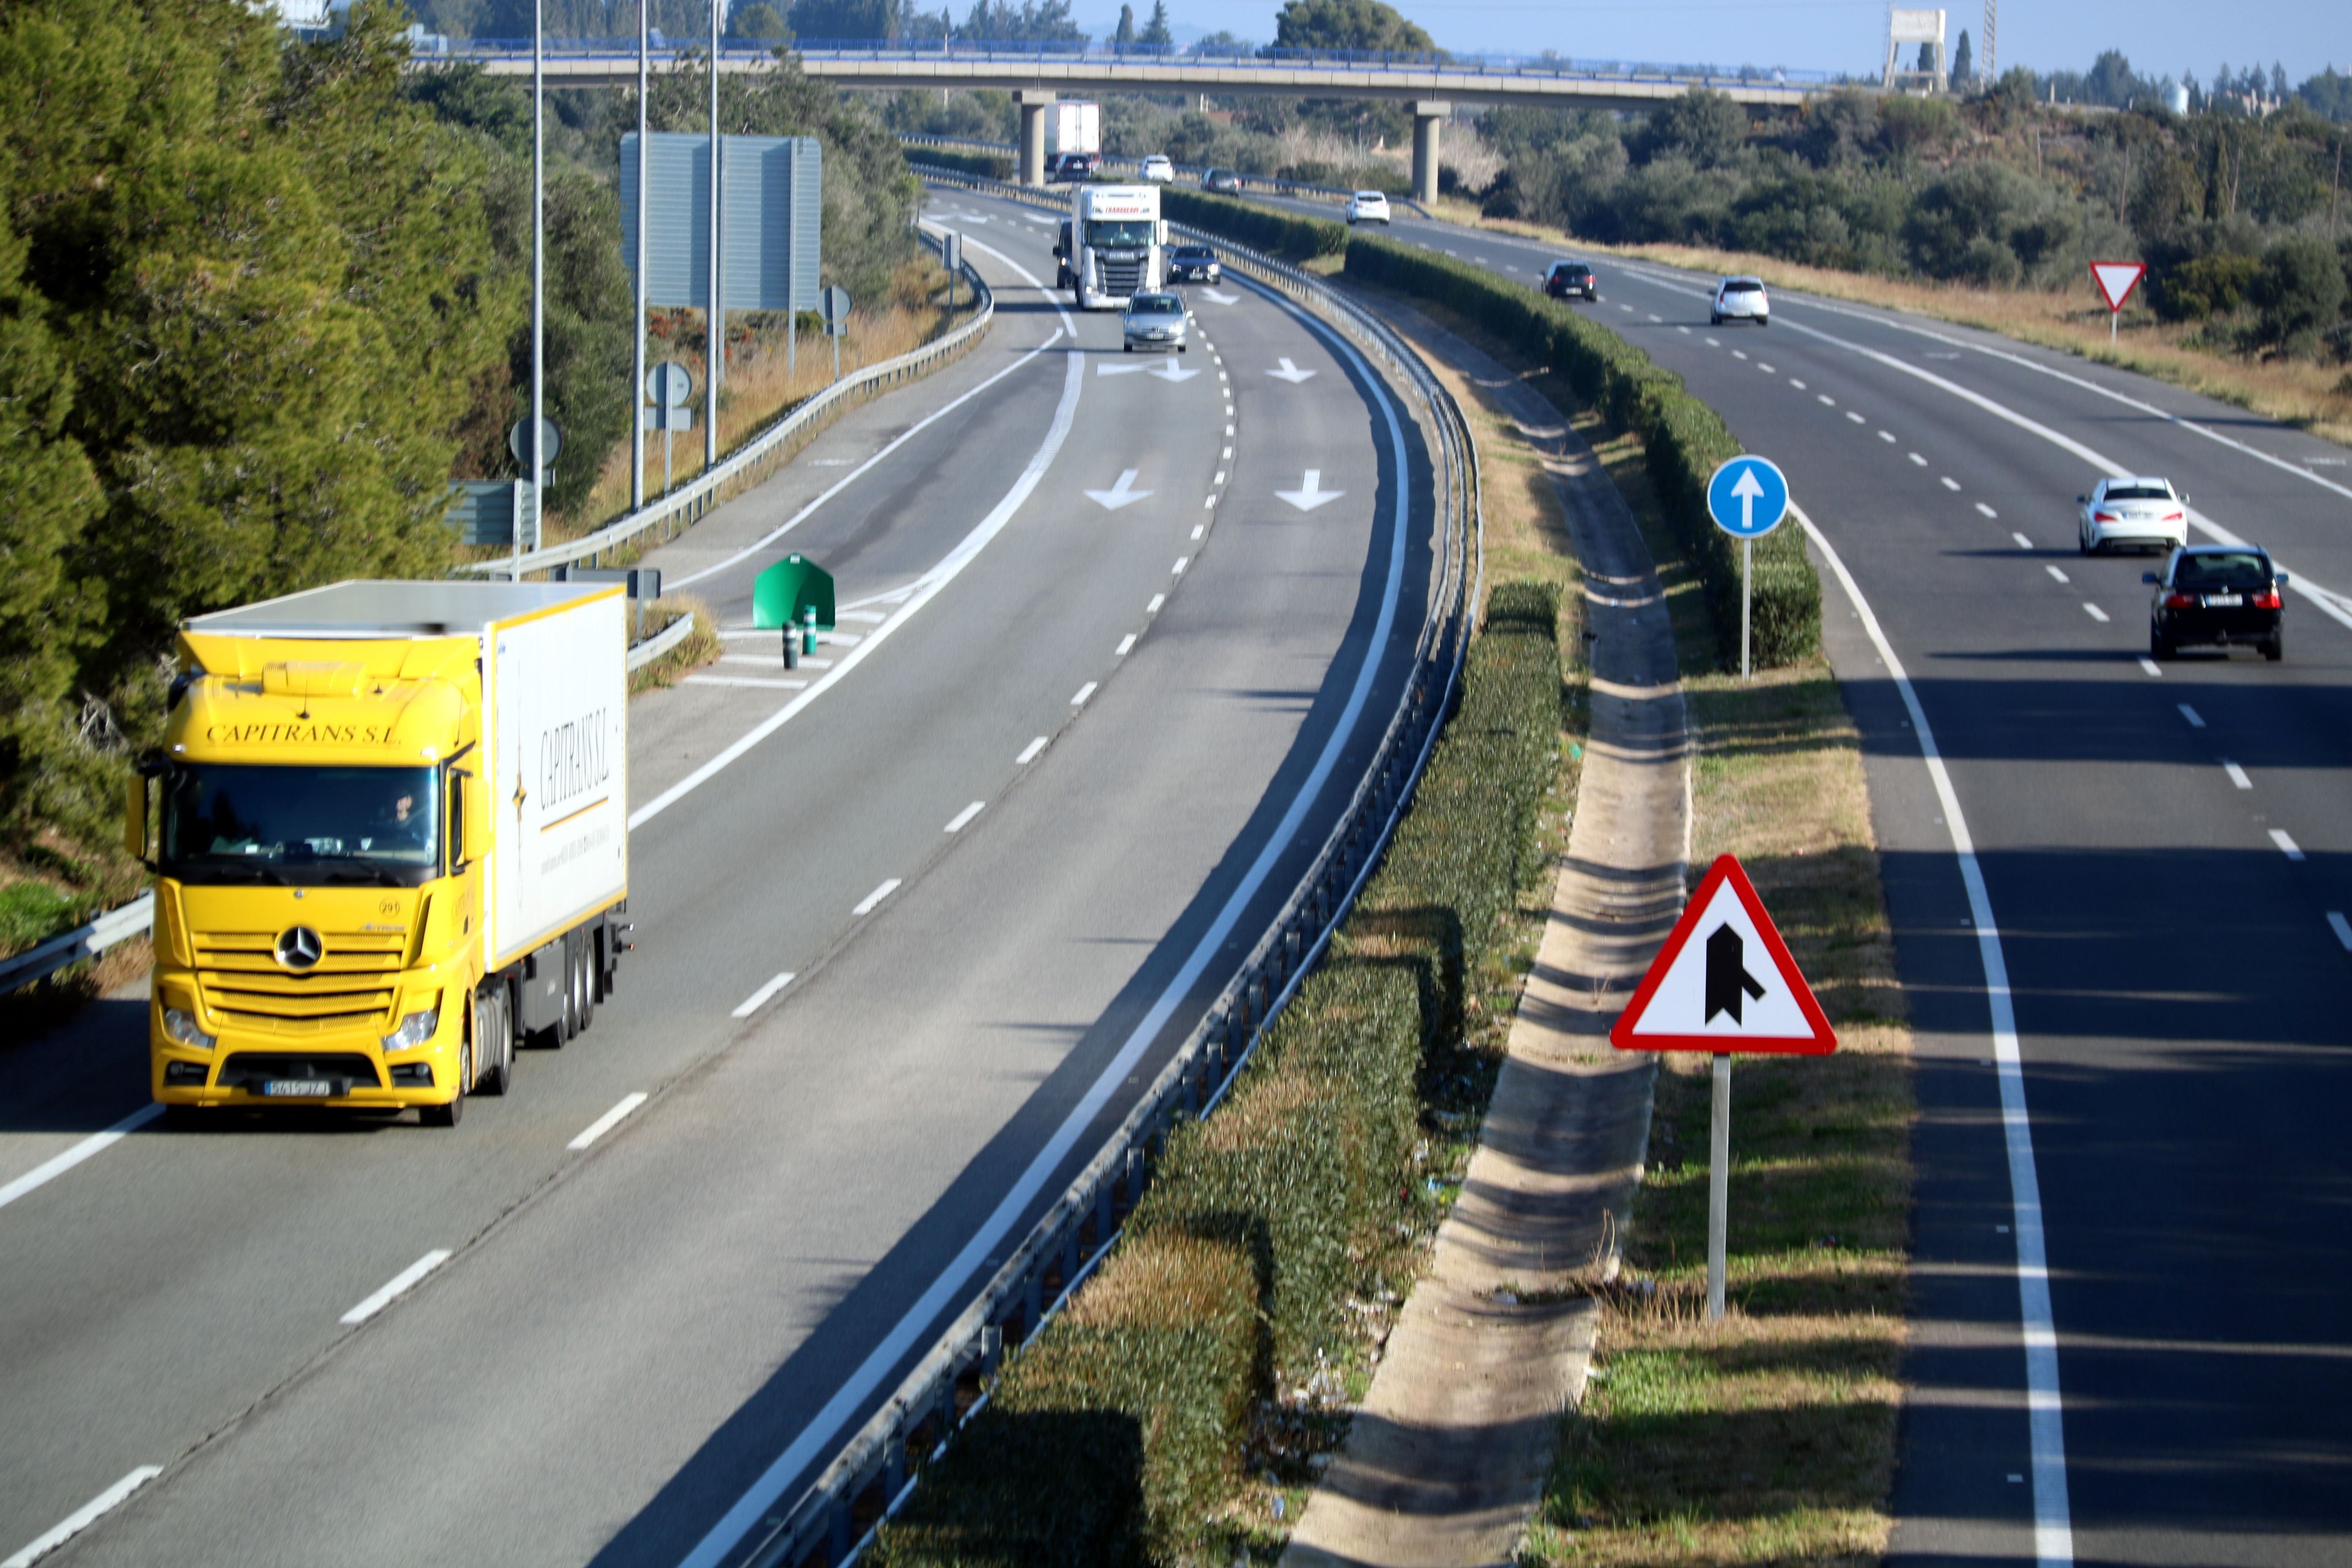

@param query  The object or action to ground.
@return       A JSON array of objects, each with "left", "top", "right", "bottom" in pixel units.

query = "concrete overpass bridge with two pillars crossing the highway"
[{"left": 416, "top": 37, "right": 1834, "bottom": 202}]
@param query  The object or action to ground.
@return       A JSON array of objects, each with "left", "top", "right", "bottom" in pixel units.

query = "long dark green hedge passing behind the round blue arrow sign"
[{"left": 1348, "top": 235, "right": 1821, "bottom": 668}]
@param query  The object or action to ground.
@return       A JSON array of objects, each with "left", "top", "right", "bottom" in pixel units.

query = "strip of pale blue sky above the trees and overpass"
[{"left": 1101, "top": 0, "right": 2352, "bottom": 82}]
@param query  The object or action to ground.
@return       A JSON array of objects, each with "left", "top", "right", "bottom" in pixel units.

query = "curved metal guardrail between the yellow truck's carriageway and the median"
[{"left": 732, "top": 169, "right": 1484, "bottom": 1568}]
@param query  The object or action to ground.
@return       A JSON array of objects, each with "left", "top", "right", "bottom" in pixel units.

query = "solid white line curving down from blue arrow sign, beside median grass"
[{"left": 1788, "top": 500, "right": 2075, "bottom": 1568}]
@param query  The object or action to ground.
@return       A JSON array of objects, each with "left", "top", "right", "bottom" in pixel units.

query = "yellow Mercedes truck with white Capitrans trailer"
[{"left": 124, "top": 583, "right": 628, "bottom": 1126}]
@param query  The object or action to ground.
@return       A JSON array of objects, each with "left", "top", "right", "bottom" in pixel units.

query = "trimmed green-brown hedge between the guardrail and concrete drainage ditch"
[{"left": 873, "top": 583, "right": 1559, "bottom": 1568}]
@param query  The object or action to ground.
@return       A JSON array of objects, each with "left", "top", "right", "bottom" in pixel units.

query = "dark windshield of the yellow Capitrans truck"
[{"left": 162, "top": 761, "right": 440, "bottom": 886}]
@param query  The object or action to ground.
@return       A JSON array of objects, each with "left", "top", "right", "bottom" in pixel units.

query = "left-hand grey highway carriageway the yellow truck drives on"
[{"left": 0, "top": 198, "right": 1430, "bottom": 1563}]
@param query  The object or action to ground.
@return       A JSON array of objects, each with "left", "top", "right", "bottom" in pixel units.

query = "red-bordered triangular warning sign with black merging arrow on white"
[{"left": 1609, "top": 856, "right": 1837, "bottom": 1055}]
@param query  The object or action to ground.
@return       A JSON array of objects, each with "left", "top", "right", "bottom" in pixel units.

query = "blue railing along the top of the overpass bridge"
[{"left": 416, "top": 35, "right": 1839, "bottom": 87}]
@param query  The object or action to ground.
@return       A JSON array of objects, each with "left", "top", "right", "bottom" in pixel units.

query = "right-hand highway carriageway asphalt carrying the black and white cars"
[{"left": 1345, "top": 208, "right": 2352, "bottom": 1568}]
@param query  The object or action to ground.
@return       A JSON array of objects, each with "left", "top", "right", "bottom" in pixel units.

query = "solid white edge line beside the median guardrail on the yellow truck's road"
[{"left": 680, "top": 251, "right": 1411, "bottom": 1568}]
